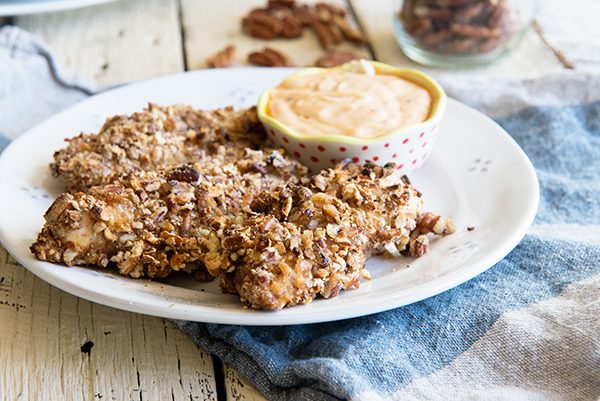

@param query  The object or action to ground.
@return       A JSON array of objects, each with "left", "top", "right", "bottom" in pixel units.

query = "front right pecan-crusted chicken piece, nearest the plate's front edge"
[{"left": 213, "top": 164, "right": 453, "bottom": 309}]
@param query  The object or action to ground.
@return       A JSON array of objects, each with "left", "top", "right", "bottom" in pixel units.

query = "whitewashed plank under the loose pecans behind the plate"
[{"left": 181, "top": 0, "right": 370, "bottom": 69}]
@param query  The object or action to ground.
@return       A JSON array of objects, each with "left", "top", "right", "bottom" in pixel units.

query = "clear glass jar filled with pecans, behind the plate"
[{"left": 394, "top": 0, "right": 537, "bottom": 67}]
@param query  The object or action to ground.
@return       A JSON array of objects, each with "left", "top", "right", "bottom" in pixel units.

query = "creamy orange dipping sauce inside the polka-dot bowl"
[{"left": 268, "top": 72, "right": 432, "bottom": 138}]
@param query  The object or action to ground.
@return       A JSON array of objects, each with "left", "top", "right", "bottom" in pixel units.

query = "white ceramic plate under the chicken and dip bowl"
[{"left": 0, "top": 68, "right": 539, "bottom": 325}]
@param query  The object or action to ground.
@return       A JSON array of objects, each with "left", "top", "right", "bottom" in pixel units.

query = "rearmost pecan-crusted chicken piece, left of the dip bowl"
[{"left": 50, "top": 104, "right": 265, "bottom": 192}]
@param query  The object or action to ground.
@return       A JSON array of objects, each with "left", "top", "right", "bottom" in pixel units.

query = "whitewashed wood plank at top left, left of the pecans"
[{"left": 14, "top": 0, "right": 183, "bottom": 84}]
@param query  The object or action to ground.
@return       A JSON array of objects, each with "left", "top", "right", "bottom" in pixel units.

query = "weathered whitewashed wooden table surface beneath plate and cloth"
[{"left": 0, "top": 0, "right": 600, "bottom": 401}]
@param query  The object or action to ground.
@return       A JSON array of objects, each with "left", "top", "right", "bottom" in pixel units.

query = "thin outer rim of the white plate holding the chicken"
[{"left": 0, "top": 67, "right": 540, "bottom": 326}]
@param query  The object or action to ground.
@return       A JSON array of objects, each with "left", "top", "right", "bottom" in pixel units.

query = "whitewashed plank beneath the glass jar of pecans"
[{"left": 350, "top": 0, "right": 563, "bottom": 76}]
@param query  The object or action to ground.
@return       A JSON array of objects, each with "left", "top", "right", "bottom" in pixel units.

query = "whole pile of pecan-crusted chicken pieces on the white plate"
[{"left": 31, "top": 104, "right": 454, "bottom": 309}]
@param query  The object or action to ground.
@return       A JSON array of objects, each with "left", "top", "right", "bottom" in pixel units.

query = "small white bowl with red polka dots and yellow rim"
[{"left": 258, "top": 61, "right": 446, "bottom": 174}]
